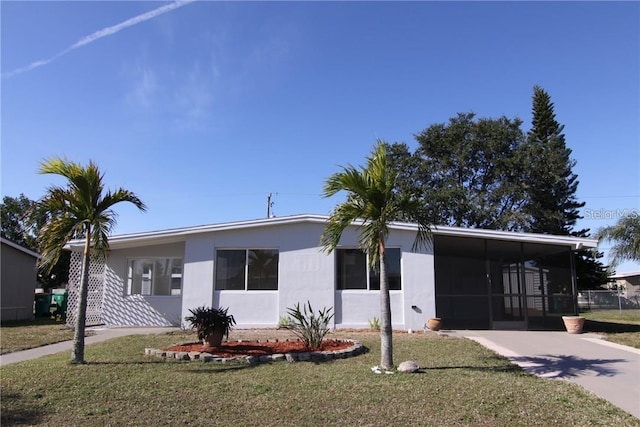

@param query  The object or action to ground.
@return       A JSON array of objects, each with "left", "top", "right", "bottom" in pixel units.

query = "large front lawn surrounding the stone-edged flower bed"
[{"left": 0, "top": 331, "right": 640, "bottom": 426}]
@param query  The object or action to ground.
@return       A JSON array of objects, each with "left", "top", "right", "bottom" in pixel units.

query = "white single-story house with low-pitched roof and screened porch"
[{"left": 62, "top": 215, "right": 597, "bottom": 330}]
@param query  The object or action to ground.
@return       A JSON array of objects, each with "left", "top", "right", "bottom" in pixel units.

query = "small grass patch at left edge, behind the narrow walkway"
[{"left": 0, "top": 318, "right": 73, "bottom": 354}]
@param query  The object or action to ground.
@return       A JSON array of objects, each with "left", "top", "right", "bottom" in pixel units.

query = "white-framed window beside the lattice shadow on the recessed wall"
[{"left": 127, "top": 258, "right": 182, "bottom": 296}]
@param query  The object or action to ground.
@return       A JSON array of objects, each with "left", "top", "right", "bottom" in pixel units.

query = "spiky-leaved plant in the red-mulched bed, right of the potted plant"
[{"left": 287, "top": 301, "right": 334, "bottom": 349}]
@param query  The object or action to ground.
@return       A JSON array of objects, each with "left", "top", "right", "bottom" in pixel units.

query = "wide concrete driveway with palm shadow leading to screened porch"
[{"left": 458, "top": 331, "right": 640, "bottom": 418}]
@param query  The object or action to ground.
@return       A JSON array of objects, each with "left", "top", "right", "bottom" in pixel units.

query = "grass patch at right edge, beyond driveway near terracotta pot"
[{"left": 580, "top": 310, "right": 640, "bottom": 349}]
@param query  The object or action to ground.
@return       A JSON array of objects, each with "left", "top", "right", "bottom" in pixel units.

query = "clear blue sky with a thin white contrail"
[{"left": 0, "top": 1, "right": 640, "bottom": 271}]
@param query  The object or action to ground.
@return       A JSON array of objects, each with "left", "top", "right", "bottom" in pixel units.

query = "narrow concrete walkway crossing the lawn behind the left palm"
[{"left": 0, "top": 327, "right": 178, "bottom": 366}]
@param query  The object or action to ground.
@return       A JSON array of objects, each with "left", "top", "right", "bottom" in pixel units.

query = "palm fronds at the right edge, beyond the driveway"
[{"left": 596, "top": 216, "right": 640, "bottom": 265}]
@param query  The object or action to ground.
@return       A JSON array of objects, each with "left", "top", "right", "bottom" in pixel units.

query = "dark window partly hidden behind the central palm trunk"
[{"left": 336, "top": 248, "right": 402, "bottom": 290}]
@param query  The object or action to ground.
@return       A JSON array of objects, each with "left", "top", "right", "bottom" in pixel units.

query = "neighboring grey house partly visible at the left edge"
[{"left": 0, "top": 237, "right": 40, "bottom": 321}]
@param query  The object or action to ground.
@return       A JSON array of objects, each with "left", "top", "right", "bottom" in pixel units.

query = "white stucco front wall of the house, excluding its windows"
[{"left": 104, "top": 217, "right": 435, "bottom": 330}]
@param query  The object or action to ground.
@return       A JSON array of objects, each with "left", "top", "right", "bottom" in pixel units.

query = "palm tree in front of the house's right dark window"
[{"left": 320, "top": 141, "right": 431, "bottom": 369}]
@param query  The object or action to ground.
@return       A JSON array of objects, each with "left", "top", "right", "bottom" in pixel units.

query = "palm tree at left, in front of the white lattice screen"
[{"left": 38, "top": 157, "right": 147, "bottom": 363}]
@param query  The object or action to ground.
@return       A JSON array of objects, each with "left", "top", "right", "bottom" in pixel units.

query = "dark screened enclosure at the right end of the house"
[{"left": 434, "top": 235, "right": 575, "bottom": 329}]
